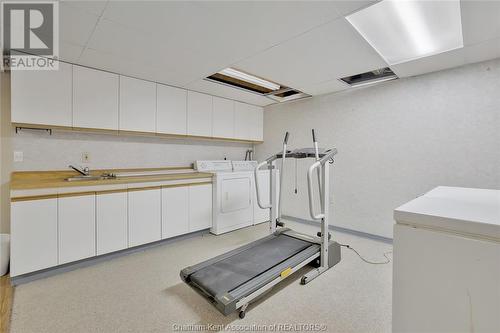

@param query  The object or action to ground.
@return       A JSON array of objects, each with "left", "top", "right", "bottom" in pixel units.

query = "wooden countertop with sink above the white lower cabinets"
[{"left": 10, "top": 167, "right": 212, "bottom": 190}]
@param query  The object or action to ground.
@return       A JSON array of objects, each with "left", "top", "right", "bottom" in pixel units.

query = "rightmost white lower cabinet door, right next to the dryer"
[{"left": 189, "top": 184, "right": 212, "bottom": 231}]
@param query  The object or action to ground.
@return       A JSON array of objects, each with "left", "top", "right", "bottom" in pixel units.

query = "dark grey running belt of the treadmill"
[{"left": 190, "top": 234, "right": 314, "bottom": 296}]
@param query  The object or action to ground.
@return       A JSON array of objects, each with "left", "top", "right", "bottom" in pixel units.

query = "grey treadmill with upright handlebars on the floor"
[{"left": 180, "top": 130, "right": 341, "bottom": 318}]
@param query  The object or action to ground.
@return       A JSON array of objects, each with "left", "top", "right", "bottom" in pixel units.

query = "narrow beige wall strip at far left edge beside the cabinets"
[{"left": 0, "top": 72, "right": 12, "bottom": 233}]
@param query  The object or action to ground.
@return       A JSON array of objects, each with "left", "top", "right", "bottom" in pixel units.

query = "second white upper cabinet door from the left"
[{"left": 73, "top": 65, "right": 118, "bottom": 130}]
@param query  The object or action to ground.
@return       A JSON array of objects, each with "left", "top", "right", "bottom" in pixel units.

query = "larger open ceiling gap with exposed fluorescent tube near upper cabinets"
[{"left": 205, "top": 68, "right": 310, "bottom": 103}]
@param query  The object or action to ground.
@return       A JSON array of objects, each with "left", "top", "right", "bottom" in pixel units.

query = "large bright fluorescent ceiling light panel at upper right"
[{"left": 346, "top": 0, "right": 464, "bottom": 65}]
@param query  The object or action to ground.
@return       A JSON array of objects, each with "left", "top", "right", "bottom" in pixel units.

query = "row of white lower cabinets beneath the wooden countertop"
[{"left": 11, "top": 184, "right": 212, "bottom": 277}]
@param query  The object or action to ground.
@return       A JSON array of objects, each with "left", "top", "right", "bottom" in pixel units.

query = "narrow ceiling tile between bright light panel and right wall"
[{"left": 391, "top": 48, "right": 465, "bottom": 77}]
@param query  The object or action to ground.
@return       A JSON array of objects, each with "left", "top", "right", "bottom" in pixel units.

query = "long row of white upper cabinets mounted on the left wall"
[{"left": 11, "top": 62, "right": 263, "bottom": 141}]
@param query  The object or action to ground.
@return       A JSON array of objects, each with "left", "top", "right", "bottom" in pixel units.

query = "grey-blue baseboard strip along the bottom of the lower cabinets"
[{"left": 10, "top": 229, "right": 210, "bottom": 286}]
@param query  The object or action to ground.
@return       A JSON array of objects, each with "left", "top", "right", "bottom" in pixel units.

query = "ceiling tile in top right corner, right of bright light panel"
[{"left": 460, "top": 0, "right": 500, "bottom": 46}]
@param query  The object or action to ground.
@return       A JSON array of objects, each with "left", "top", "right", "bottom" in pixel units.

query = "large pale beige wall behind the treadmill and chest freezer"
[{"left": 256, "top": 59, "right": 500, "bottom": 237}]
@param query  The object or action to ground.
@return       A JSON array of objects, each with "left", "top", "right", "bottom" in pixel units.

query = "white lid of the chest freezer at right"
[{"left": 394, "top": 186, "right": 500, "bottom": 241}]
